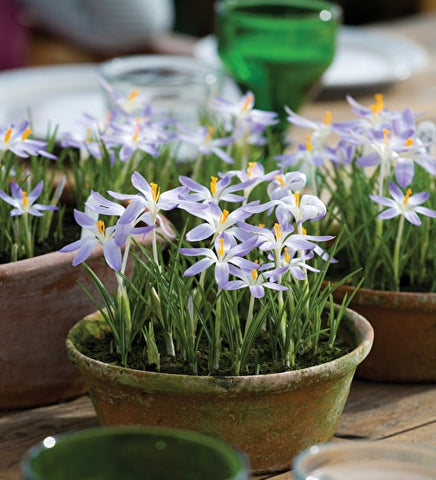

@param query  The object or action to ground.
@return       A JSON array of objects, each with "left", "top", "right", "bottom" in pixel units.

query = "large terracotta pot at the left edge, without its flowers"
[{"left": 0, "top": 227, "right": 167, "bottom": 409}]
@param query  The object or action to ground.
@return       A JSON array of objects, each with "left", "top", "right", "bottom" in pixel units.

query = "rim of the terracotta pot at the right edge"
[{"left": 338, "top": 285, "right": 436, "bottom": 311}]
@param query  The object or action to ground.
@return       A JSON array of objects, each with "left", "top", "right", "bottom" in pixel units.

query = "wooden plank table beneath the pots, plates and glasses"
[{"left": 0, "top": 13, "right": 436, "bottom": 480}]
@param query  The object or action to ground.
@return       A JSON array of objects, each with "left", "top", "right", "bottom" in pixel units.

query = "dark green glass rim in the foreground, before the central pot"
[{"left": 21, "top": 426, "right": 248, "bottom": 480}]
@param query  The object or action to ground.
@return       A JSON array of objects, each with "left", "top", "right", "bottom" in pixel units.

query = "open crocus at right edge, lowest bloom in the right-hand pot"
[{"left": 370, "top": 182, "right": 436, "bottom": 226}]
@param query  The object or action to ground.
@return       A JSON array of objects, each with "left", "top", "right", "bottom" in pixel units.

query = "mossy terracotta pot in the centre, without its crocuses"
[{"left": 67, "top": 310, "right": 373, "bottom": 473}]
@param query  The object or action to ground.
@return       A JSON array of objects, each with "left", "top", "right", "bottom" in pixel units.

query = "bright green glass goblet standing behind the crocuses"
[{"left": 216, "top": 0, "right": 342, "bottom": 126}]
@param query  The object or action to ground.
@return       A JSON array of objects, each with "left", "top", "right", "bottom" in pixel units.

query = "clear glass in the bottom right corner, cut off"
[{"left": 292, "top": 440, "right": 436, "bottom": 480}]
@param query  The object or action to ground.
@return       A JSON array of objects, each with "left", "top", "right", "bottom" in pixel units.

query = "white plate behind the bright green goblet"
[{"left": 194, "top": 26, "right": 430, "bottom": 91}]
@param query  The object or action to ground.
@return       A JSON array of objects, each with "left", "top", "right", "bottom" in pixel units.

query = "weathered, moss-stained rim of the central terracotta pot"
[{"left": 66, "top": 309, "right": 374, "bottom": 395}]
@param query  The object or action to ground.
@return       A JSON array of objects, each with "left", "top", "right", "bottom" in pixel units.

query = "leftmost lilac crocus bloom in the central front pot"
[{"left": 60, "top": 210, "right": 122, "bottom": 271}]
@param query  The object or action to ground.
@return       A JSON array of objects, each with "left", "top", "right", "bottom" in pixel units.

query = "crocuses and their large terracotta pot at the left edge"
[{"left": 0, "top": 89, "right": 178, "bottom": 409}]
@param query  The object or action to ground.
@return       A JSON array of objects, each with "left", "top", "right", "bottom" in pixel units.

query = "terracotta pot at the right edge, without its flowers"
[{"left": 335, "top": 286, "right": 436, "bottom": 383}]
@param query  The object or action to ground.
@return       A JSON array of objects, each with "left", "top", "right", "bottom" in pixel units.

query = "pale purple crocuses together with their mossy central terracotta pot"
[{"left": 63, "top": 93, "right": 372, "bottom": 473}]
